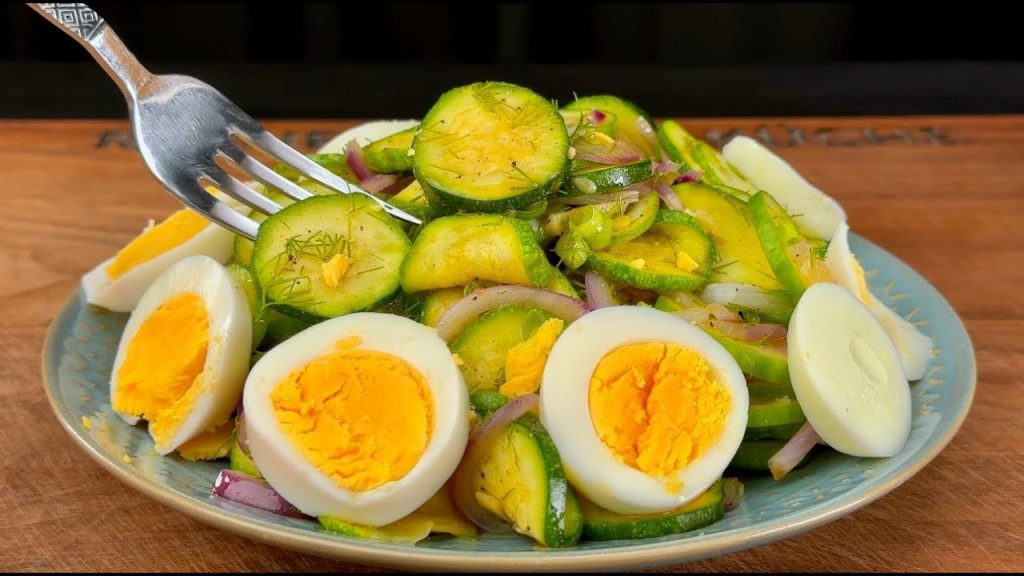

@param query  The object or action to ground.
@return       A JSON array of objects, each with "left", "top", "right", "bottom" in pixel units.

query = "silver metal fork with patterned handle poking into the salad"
[{"left": 29, "top": 3, "right": 420, "bottom": 239}]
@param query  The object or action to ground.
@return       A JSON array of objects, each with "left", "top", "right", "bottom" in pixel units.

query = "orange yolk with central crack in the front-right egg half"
[{"left": 589, "top": 342, "right": 731, "bottom": 489}]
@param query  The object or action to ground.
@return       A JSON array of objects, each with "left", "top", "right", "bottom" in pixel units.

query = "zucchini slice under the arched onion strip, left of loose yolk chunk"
[{"left": 452, "top": 304, "right": 553, "bottom": 393}]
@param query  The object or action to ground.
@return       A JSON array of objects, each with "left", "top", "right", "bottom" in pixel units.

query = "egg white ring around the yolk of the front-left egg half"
[{"left": 243, "top": 313, "right": 469, "bottom": 526}]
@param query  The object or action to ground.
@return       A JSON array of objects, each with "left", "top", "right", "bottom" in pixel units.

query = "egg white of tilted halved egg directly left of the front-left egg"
[{"left": 111, "top": 254, "right": 252, "bottom": 454}]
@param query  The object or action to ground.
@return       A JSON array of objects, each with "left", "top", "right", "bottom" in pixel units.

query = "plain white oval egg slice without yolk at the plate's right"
[{"left": 787, "top": 283, "right": 910, "bottom": 457}]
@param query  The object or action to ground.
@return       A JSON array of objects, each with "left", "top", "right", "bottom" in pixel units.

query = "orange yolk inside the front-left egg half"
[{"left": 270, "top": 340, "right": 434, "bottom": 491}]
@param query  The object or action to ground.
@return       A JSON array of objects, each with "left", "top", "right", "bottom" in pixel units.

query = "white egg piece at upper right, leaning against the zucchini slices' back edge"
[{"left": 722, "top": 135, "right": 846, "bottom": 239}]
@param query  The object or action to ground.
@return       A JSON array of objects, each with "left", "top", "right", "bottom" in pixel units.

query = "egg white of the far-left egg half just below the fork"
[{"left": 82, "top": 212, "right": 234, "bottom": 312}]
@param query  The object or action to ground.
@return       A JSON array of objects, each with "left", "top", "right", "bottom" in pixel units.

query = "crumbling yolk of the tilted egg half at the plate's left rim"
[{"left": 113, "top": 292, "right": 209, "bottom": 447}]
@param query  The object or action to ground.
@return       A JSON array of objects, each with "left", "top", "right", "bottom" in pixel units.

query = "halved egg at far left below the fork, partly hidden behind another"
[{"left": 82, "top": 208, "right": 234, "bottom": 312}]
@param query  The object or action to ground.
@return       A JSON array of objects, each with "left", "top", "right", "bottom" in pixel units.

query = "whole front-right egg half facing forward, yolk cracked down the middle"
[{"left": 541, "top": 306, "right": 749, "bottom": 513}]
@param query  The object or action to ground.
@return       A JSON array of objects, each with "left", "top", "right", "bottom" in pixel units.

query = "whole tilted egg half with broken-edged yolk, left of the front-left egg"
[{"left": 111, "top": 255, "right": 252, "bottom": 454}]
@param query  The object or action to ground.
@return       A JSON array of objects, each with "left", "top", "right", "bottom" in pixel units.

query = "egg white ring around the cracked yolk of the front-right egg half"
[{"left": 541, "top": 306, "right": 750, "bottom": 513}]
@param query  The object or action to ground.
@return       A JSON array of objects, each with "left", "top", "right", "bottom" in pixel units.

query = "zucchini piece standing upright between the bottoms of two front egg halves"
[{"left": 473, "top": 414, "right": 583, "bottom": 547}]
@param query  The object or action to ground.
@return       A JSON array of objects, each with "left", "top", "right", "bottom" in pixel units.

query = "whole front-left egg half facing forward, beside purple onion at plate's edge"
[{"left": 243, "top": 313, "right": 469, "bottom": 526}]
